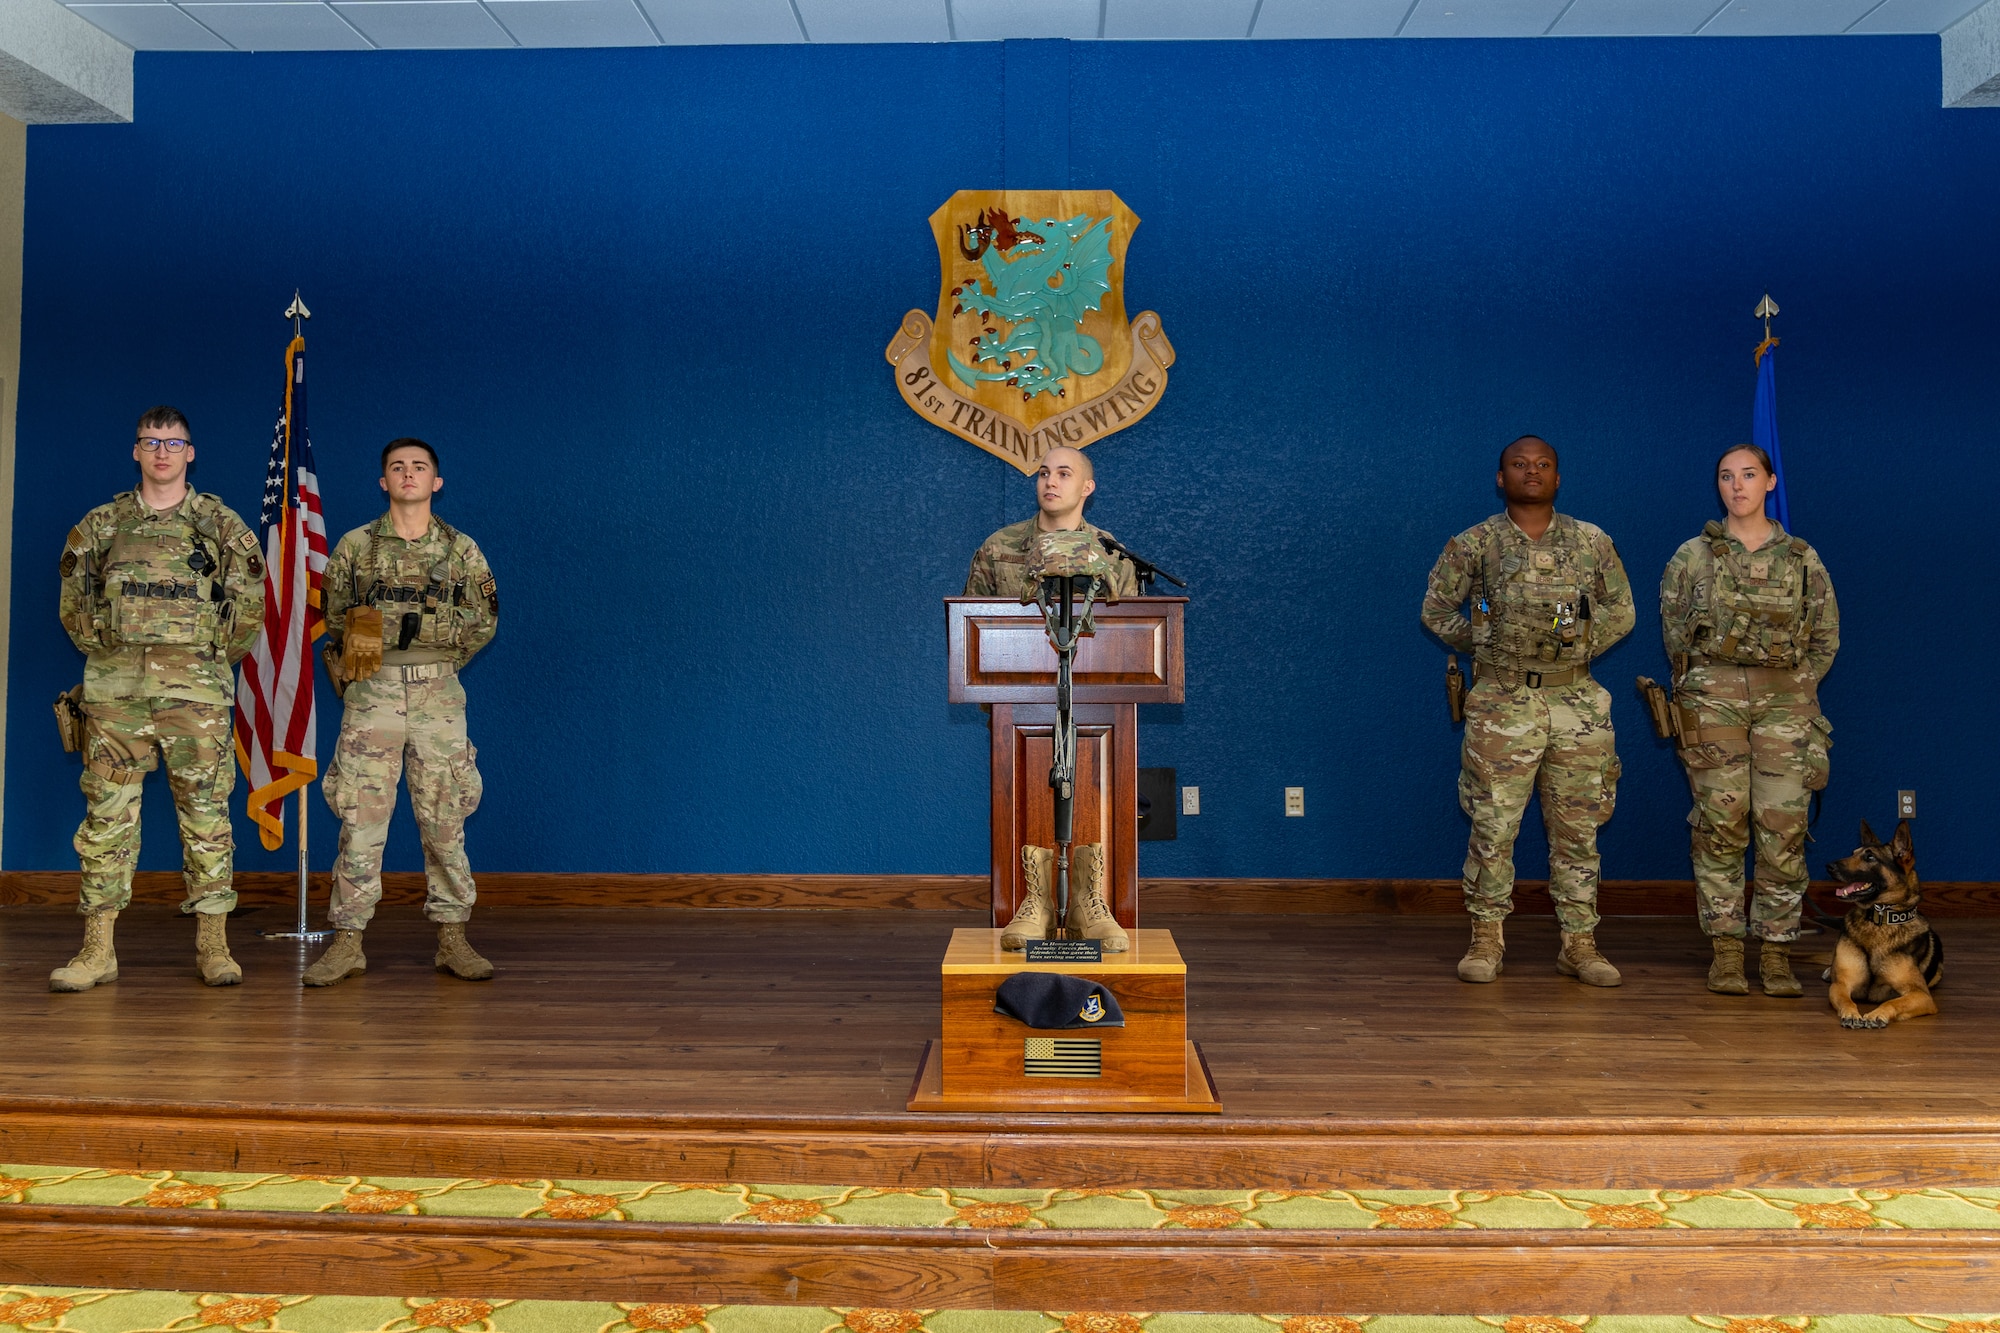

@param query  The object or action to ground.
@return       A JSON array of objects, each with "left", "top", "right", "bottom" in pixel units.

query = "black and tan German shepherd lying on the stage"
[{"left": 1826, "top": 819, "right": 1944, "bottom": 1027}]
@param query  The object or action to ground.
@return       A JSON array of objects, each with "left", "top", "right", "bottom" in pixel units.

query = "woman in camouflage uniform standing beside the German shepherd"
[{"left": 1660, "top": 446, "right": 1840, "bottom": 997}]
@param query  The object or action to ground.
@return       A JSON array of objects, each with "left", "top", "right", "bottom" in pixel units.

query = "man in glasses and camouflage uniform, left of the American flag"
[{"left": 48, "top": 406, "right": 264, "bottom": 991}]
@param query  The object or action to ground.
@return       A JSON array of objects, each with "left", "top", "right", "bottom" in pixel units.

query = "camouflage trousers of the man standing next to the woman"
[{"left": 1458, "top": 677, "right": 1618, "bottom": 935}]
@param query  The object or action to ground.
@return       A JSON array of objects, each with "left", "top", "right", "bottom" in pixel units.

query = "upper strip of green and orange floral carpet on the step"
[{"left": 0, "top": 1165, "right": 2000, "bottom": 1232}]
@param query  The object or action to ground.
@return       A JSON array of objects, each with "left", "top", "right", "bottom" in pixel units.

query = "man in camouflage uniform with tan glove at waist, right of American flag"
[{"left": 304, "top": 438, "right": 500, "bottom": 987}]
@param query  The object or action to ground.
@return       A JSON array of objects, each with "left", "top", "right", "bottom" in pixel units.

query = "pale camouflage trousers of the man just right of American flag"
[{"left": 322, "top": 667, "right": 482, "bottom": 931}]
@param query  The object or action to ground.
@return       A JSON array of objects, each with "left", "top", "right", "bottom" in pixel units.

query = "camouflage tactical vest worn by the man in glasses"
[{"left": 98, "top": 494, "right": 234, "bottom": 648}]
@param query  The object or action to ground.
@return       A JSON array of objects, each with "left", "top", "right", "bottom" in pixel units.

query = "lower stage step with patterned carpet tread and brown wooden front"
[{"left": 0, "top": 1167, "right": 2000, "bottom": 1315}]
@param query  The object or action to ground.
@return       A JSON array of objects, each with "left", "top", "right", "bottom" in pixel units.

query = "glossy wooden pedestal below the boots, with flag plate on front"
[{"left": 908, "top": 929, "right": 1222, "bottom": 1113}]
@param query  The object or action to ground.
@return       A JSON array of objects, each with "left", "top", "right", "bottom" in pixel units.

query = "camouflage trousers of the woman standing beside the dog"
[{"left": 1676, "top": 662, "right": 1832, "bottom": 941}]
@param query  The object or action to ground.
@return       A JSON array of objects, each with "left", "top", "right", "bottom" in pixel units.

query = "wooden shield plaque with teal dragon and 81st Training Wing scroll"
[{"left": 886, "top": 190, "right": 1174, "bottom": 474}]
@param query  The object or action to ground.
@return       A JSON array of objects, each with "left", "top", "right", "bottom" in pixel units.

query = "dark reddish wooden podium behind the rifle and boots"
[{"left": 944, "top": 596, "right": 1188, "bottom": 931}]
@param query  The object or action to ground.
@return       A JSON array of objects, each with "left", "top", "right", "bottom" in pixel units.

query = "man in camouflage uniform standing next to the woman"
[{"left": 1422, "top": 436, "right": 1634, "bottom": 987}]
